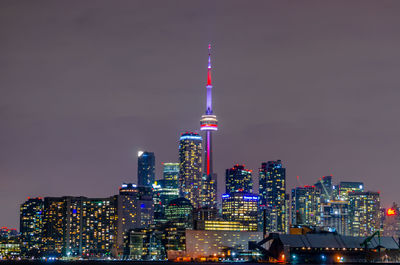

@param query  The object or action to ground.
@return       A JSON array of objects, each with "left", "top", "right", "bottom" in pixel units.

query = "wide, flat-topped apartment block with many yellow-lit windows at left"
[{"left": 25, "top": 196, "right": 117, "bottom": 257}]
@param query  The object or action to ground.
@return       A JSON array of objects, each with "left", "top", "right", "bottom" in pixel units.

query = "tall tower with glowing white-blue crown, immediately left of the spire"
[{"left": 179, "top": 132, "right": 203, "bottom": 208}]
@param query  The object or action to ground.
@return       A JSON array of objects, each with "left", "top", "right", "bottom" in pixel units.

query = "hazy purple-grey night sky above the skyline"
[{"left": 0, "top": 0, "right": 400, "bottom": 227}]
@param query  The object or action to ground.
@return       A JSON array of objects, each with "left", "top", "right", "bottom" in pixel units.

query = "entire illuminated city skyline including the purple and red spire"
[{"left": 0, "top": 46, "right": 400, "bottom": 261}]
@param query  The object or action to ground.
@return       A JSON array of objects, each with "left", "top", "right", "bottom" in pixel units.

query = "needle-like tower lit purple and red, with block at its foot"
[{"left": 200, "top": 44, "right": 218, "bottom": 208}]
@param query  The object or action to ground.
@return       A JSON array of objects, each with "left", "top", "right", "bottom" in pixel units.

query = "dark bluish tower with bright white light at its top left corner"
[{"left": 138, "top": 151, "right": 156, "bottom": 187}]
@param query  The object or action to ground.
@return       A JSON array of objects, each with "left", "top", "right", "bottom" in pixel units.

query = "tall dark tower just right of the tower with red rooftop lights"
[{"left": 258, "top": 160, "right": 289, "bottom": 232}]
